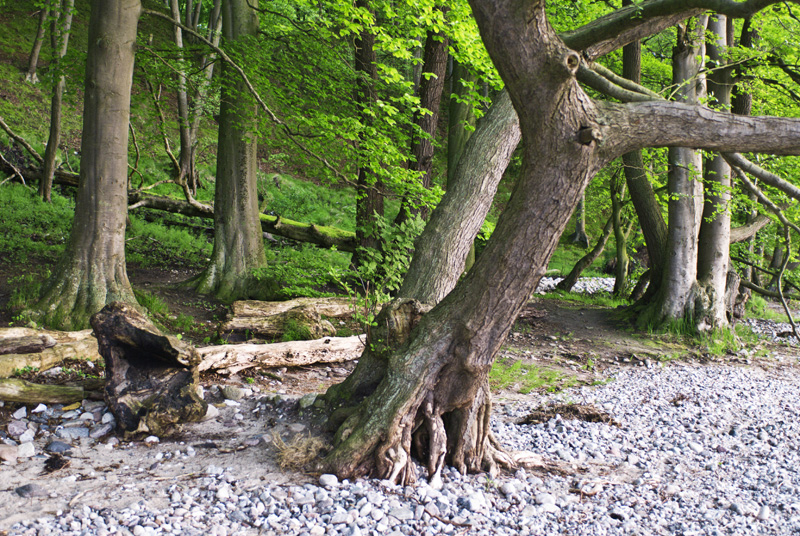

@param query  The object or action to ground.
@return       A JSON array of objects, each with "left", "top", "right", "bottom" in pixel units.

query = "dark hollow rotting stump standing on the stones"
[{"left": 91, "top": 302, "right": 208, "bottom": 435}]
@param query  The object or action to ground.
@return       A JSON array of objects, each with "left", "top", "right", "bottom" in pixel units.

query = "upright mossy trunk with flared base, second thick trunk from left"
[{"left": 196, "top": 0, "right": 267, "bottom": 302}]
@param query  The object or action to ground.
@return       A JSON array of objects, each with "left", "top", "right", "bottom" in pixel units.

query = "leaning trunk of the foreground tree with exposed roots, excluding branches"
[{"left": 322, "top": 2, "right": 600, "bottom": 486}]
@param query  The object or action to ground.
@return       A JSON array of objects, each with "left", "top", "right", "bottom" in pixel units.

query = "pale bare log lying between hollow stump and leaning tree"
[{"left": 197, "top": 335, "right": 364, "bottom": 374}]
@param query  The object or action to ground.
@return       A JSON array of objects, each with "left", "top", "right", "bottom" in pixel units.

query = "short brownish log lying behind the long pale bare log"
[{"left": 220, "top": 298, "right": 353, "bottom": 339}]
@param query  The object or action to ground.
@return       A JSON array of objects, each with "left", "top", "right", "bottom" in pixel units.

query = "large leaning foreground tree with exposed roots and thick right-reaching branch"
[{"left": 322, "top": 0, "right": 800, "bottom": 484}]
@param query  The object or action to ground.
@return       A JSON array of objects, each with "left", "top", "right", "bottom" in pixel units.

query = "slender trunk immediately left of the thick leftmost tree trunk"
[{"left": 39, "top": 0, "right": 75, "bottom": 203}]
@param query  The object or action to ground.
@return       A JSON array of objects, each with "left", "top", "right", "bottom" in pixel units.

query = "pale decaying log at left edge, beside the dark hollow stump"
[{"left": 0, "top": 328, "right": 100, "bottom": 378}]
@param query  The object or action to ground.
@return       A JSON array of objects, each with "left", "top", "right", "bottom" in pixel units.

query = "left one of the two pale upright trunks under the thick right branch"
[{"left": 640, "top": 16, "right": 707, "bottom": 325}]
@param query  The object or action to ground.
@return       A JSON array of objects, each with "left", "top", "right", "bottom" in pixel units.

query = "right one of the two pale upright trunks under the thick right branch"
[{"left": 695, "top": 15, "right": 731, "bottom": 331}]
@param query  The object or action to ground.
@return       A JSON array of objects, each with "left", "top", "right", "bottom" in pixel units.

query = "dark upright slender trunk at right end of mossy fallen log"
[{"left": 353, "top": 0, "right": 383, "bottom": 267}]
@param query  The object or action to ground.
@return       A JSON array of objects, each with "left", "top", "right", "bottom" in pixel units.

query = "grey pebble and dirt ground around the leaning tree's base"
[{"left": 0, "top": 274, "right": 800, "bottom": 536}]
